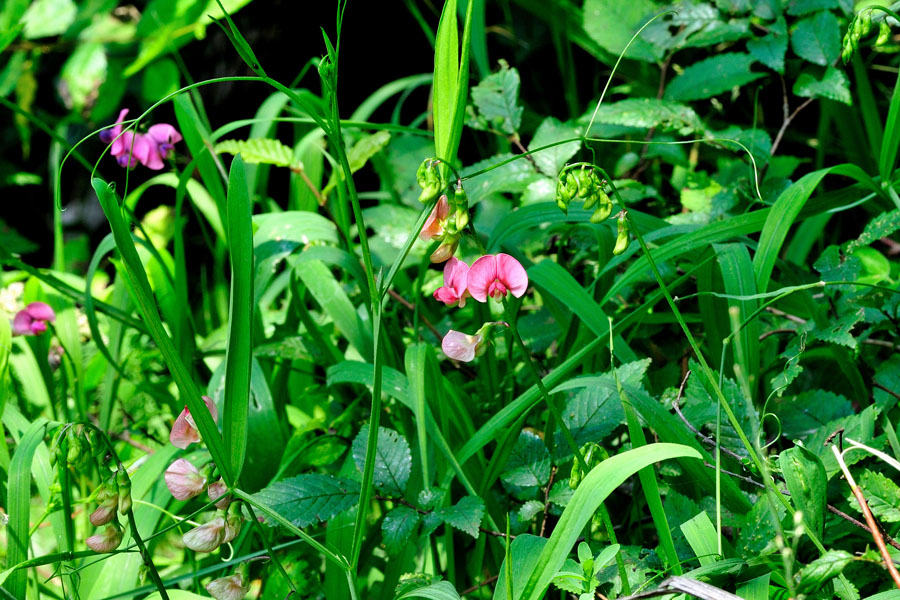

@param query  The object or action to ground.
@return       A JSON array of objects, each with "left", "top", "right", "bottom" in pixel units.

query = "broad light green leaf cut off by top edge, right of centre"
[{"left": 584, "top": 0, "right": 664, "bottom": 62}]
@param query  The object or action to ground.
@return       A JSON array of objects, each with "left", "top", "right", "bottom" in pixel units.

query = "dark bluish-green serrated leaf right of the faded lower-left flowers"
[{"left": 253, "top": 473, "right": 359, "bottom": 527}]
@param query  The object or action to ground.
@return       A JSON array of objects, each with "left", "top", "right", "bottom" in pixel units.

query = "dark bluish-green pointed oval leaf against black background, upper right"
[{"left": 665, "top": 52, "right": 765, "bottom": 100}]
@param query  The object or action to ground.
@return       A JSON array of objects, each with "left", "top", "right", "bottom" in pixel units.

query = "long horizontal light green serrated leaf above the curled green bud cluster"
[{"left": 579, "top": 98, "right": 703, "bottom": 135}]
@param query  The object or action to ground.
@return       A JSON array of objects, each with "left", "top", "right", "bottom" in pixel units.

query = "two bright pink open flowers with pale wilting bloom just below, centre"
[{"left": 434, "top": 252, "right": 528, "bottom": 362}]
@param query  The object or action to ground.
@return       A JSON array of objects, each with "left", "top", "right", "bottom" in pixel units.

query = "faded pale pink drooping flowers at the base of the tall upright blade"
[{"left": 164, "top": 396, "right": 243, "bottom": 552}]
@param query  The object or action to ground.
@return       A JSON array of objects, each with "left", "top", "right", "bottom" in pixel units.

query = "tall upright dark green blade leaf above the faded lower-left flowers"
[{"left": 222, "top": 155, "right": 254, "bottom": 479}]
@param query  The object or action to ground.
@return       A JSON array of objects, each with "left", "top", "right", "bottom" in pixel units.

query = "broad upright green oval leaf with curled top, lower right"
[{"left": 778, "top": 446, "right": 828, "bottom": 538}]
